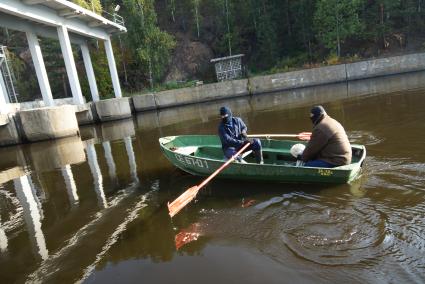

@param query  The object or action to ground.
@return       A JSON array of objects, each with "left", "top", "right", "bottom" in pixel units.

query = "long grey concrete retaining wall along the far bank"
[{"left": 132, "top": 53, "right": 425, "bottom": 112}]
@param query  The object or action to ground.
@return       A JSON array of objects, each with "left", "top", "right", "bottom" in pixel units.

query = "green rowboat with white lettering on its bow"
[{"left": 159, "top": 135, "right": 366, "bottom": 183}]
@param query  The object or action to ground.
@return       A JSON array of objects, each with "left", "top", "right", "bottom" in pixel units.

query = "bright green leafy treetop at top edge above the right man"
[{"left": 314, "top": 0, "right": 363, "bottom": 56}]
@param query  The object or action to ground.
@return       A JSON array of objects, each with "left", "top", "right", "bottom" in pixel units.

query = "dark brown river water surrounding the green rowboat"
[{"left": 0, "top": 77, "right": 425, "bottom": 283}]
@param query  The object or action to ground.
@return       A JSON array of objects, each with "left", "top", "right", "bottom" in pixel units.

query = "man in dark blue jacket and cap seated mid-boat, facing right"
[{"left": 218, "top": 106, "right": 263, "bottom": 164}]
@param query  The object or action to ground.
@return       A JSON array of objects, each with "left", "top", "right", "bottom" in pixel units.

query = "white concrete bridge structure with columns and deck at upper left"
[{"left": 0, "top": 0, "right": 131, "bottom": 145}]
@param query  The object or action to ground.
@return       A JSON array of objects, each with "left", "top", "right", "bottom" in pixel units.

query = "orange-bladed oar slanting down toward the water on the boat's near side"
[{"left": 167, "top": 143, "right": 250, "bottom": 217}]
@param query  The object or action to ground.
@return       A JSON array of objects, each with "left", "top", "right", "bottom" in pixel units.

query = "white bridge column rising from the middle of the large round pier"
[{"left": 26, "top": 32, "right": 55, "bottom": 106}]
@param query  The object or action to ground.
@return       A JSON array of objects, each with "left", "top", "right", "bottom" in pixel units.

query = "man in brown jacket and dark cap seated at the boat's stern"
[{"left": 301, "top": 106, "right": 351, "bottom": 168}]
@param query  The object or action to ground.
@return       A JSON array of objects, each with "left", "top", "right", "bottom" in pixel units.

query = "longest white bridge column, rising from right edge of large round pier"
[{"left": 58, "top": 26, "right": 84, "bottom": 105}]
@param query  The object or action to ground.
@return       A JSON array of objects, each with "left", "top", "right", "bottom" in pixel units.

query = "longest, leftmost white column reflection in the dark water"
[{"left": 13, "top": 176, "right": 49, "bottom": 260}]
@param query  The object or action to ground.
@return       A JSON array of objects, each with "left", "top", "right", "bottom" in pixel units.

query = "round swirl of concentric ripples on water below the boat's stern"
[{"left": 281, "top": 200, "right": 385, "bottom": 265}]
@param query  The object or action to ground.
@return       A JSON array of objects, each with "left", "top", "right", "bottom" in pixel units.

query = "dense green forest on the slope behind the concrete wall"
[{"left": 0, "top": 0, "right": 425, "bottom": 101}]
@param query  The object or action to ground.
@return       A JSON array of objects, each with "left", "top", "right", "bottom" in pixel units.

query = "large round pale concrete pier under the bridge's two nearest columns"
[{"left": 18, "top": 105, "right": 79, "bottom": 142}]
